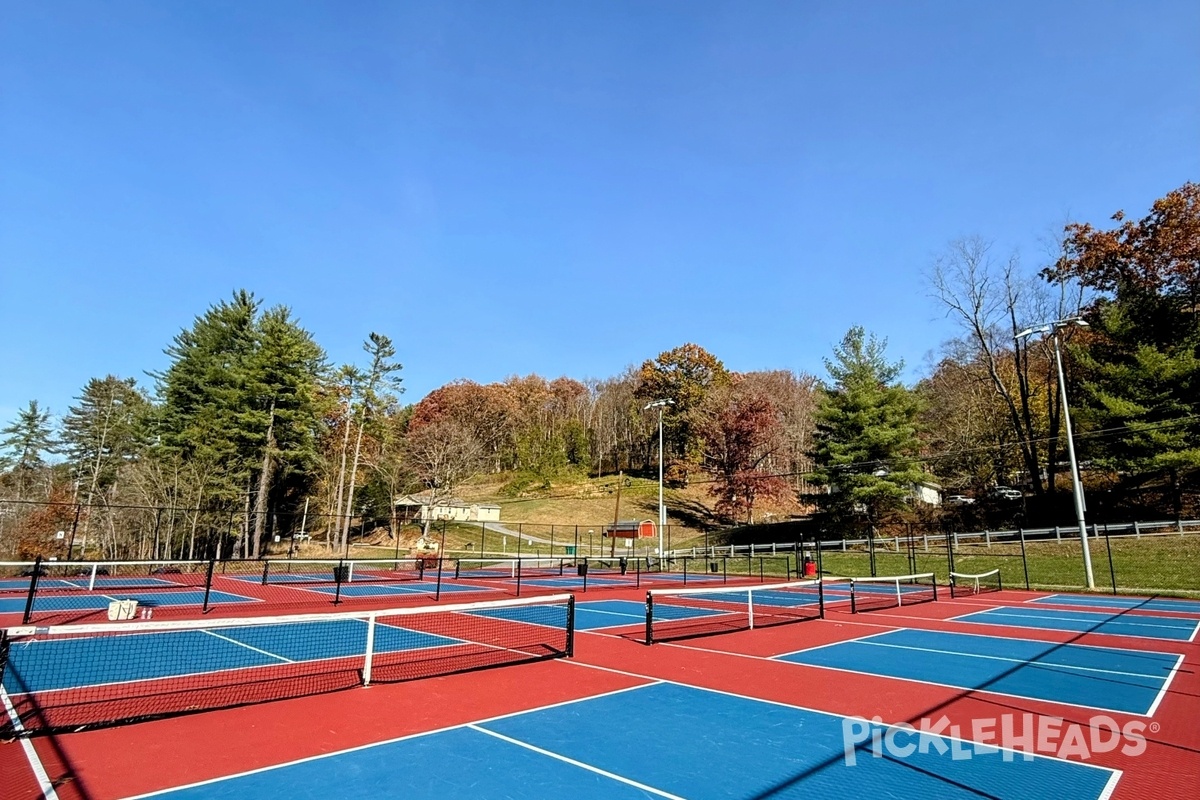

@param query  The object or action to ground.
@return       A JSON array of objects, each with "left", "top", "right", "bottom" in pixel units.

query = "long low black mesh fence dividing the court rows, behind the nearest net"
[{"left": 0, "top": 553, "right": 803, "bottom": 625}]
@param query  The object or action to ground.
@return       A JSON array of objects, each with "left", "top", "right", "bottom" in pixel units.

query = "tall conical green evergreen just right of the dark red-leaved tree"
[{"left": 814, "top": 327, "right": 925, "bottom": 524}]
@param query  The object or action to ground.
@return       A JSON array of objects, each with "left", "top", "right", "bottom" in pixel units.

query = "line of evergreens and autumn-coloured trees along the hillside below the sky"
[{"left": 0, "top": 184, "right": 1200, "bottom": 558}]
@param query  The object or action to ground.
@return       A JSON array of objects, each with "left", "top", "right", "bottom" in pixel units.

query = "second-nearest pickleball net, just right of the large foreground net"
[{"left": 646, "top": 581, "right": 824, "bottom": 644}]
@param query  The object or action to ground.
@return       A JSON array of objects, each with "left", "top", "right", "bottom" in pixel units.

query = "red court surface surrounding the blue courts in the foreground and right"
[{"left": 0, "top": 588, "right": 1200, "bottom": 800}]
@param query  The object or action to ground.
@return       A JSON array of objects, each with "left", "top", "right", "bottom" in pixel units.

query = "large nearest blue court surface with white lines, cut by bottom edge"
[{"left": 142, "top": 684, "right": 1120, "bottom": 800}]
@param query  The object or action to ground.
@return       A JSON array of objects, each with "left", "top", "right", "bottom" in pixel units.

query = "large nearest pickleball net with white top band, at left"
[{"left": 0, "top": 594, "right": 575, "bottom": 736}]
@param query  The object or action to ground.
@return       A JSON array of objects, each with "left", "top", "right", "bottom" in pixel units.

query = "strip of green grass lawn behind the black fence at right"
[{"left": 822, "top": 534, "right": 1200, "bottom": 596}]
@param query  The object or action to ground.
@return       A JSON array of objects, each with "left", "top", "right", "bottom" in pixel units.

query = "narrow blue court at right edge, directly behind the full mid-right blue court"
[{"left": 950, "top": 606, "right": 1200, "bottom": 642}]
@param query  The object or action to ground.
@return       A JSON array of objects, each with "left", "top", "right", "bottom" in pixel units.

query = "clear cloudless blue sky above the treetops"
[{"left": 0, "top": 0, "right": 1200, "bottom": 422}]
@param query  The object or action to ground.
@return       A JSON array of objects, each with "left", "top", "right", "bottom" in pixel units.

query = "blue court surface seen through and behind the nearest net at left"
[{"left": 4, "top": 619, "right": 460, "bottom": 696}]
